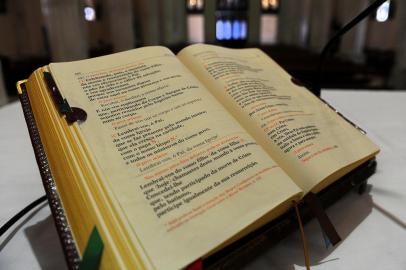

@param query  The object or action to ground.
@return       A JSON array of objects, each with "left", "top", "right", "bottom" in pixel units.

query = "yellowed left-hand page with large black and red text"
[{"left": 50, "top": 47, "right": 302, "bottom": 269}]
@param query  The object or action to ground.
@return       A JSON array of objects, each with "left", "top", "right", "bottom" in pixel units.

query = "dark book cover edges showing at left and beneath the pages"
[{"left": 19, "top": 80, "right": 376, "bottom": 269}]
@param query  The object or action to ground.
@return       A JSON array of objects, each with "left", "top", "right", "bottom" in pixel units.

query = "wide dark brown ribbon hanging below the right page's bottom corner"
[{"left": 303, "top": 192, "right": 341, "bottom": 246}]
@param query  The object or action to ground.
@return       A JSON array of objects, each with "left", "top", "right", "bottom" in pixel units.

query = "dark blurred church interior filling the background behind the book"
[{"left": 0, "top": 0, "right": 406, "bottom": 105}]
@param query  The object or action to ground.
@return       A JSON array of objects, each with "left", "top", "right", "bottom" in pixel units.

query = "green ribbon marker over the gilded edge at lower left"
[{"left": 79, "top": 226, "right": 104, "bottom": 270}]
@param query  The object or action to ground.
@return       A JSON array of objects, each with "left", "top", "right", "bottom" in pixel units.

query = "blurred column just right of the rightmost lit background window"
[{"left": 278, "top": 0, "right": 312, "bottom": 47}]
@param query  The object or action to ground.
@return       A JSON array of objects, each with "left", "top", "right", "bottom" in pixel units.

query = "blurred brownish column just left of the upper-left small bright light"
[{"left": 41, "top": 0, "right": 88, "bottom": 61}]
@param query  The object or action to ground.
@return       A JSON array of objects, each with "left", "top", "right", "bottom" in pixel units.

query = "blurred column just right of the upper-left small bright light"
[{"left": 103, "top": 0, "right": 135, "bottom": 52}]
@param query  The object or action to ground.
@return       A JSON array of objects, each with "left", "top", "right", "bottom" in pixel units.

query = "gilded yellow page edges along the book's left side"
[{"left": 26, "top": 68, "right": 138, "bottom": 269}]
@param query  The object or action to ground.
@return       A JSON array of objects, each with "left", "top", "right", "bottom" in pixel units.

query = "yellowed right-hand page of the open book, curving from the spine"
[{"left": 178, "top": 44, "right": 379, "bottom": 192}]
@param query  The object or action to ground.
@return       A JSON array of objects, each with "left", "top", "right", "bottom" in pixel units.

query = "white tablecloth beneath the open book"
[{"left": 0, "top": 90, "right": 406, "bottom": 270}]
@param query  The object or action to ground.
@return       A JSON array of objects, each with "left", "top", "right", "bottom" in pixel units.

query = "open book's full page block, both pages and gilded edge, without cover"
[{"left": 17, "top": 44, "right": 379, "bottom": 269}]
